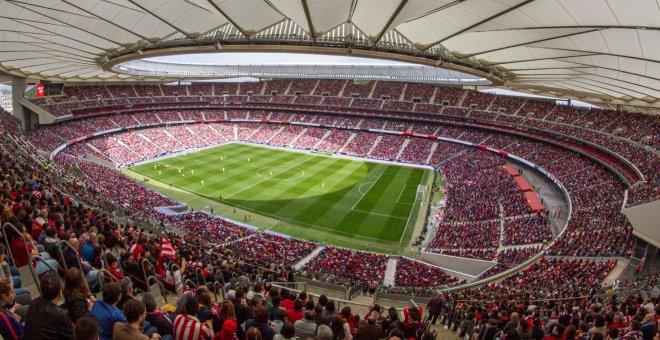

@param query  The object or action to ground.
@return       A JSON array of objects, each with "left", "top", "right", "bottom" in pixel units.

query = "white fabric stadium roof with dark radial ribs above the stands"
[{"left": 0, "top": 0, "right": 660, "bottom": 107}]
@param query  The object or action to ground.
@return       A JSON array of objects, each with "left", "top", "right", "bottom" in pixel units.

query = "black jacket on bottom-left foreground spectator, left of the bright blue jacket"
[{"left": 23, "top": 297, "right": 73, "bottom": 340}]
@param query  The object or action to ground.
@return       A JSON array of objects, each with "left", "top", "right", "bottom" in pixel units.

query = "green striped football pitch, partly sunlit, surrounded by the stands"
[{"left": 130, "top": 144, "right": 431, "bottom": 244}]
